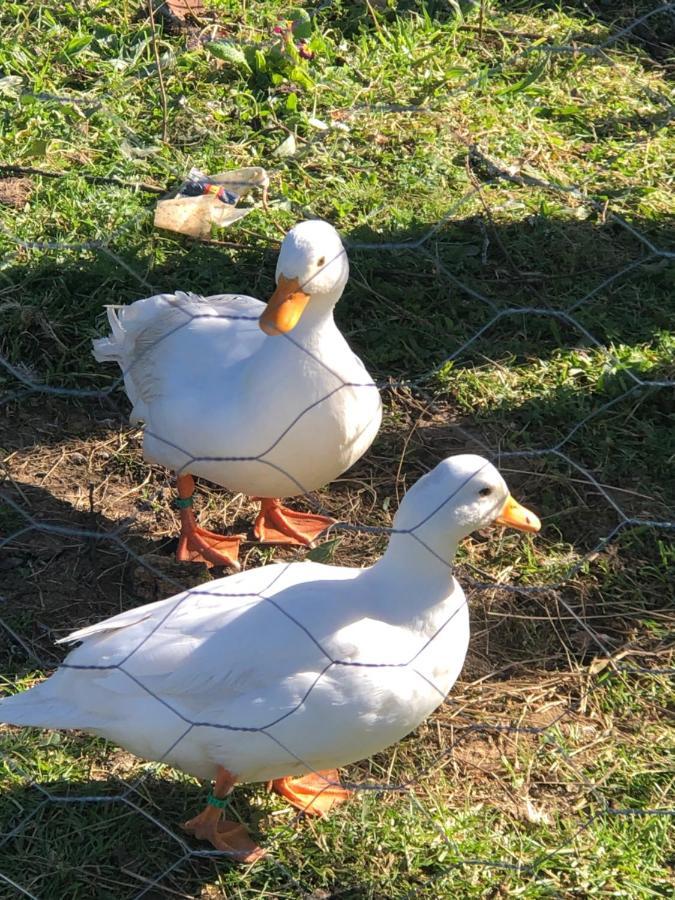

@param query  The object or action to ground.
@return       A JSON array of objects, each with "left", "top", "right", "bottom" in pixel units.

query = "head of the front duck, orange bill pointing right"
[{"left": 394, "top": 454, "right": 541, "bottom": 563}]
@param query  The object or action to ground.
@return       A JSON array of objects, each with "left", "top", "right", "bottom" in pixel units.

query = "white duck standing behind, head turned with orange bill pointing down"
[{"left": 94, "top": 221, "right": 382, "bottom": 569}]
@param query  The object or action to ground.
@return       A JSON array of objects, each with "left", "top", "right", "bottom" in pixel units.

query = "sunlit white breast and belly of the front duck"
[{"left": 217, "top": 582, "right": 469, "bottom": 781}]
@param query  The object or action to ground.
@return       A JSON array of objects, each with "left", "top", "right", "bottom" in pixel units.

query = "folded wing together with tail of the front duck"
[{"left": 0, "top": 563, "right": 317, "bottom": 736}]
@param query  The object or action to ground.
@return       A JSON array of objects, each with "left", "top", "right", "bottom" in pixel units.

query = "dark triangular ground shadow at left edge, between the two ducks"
[{"left": 0, "top": 480, "right": 227, "bottom": 672}]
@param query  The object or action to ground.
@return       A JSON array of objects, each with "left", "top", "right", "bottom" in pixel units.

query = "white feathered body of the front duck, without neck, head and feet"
[{"left": 0, "top": 563, "right": 468, "bottom": 781}]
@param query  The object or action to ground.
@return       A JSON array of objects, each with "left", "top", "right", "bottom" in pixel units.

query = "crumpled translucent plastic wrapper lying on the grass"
[{"left": 155, "top": 166, "right": 270, "bottom": 238}]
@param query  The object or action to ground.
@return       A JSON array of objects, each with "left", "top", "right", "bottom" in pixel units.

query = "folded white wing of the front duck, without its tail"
[{"left": 48, "top": 563, "right": 348, "bottom": 728}]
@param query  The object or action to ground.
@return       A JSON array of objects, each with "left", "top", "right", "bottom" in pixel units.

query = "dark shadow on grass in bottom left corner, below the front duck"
[{"left": 0, "top": 772, "right": 287, "bottom": 900}]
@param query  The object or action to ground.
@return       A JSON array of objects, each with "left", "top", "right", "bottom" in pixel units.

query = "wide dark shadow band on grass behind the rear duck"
[{"left": 0, "top": 213, "right": 675, "bottom": 388}]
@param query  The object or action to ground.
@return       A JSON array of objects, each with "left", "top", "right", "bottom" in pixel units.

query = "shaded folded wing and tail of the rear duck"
[{"left": 93, "top": 291, "right": 265, "bottom": 421}]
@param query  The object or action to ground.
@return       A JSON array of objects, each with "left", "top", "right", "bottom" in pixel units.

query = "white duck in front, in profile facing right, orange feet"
[{"left": 0, "top": 455, "right": 540, "bottom": 861}]
